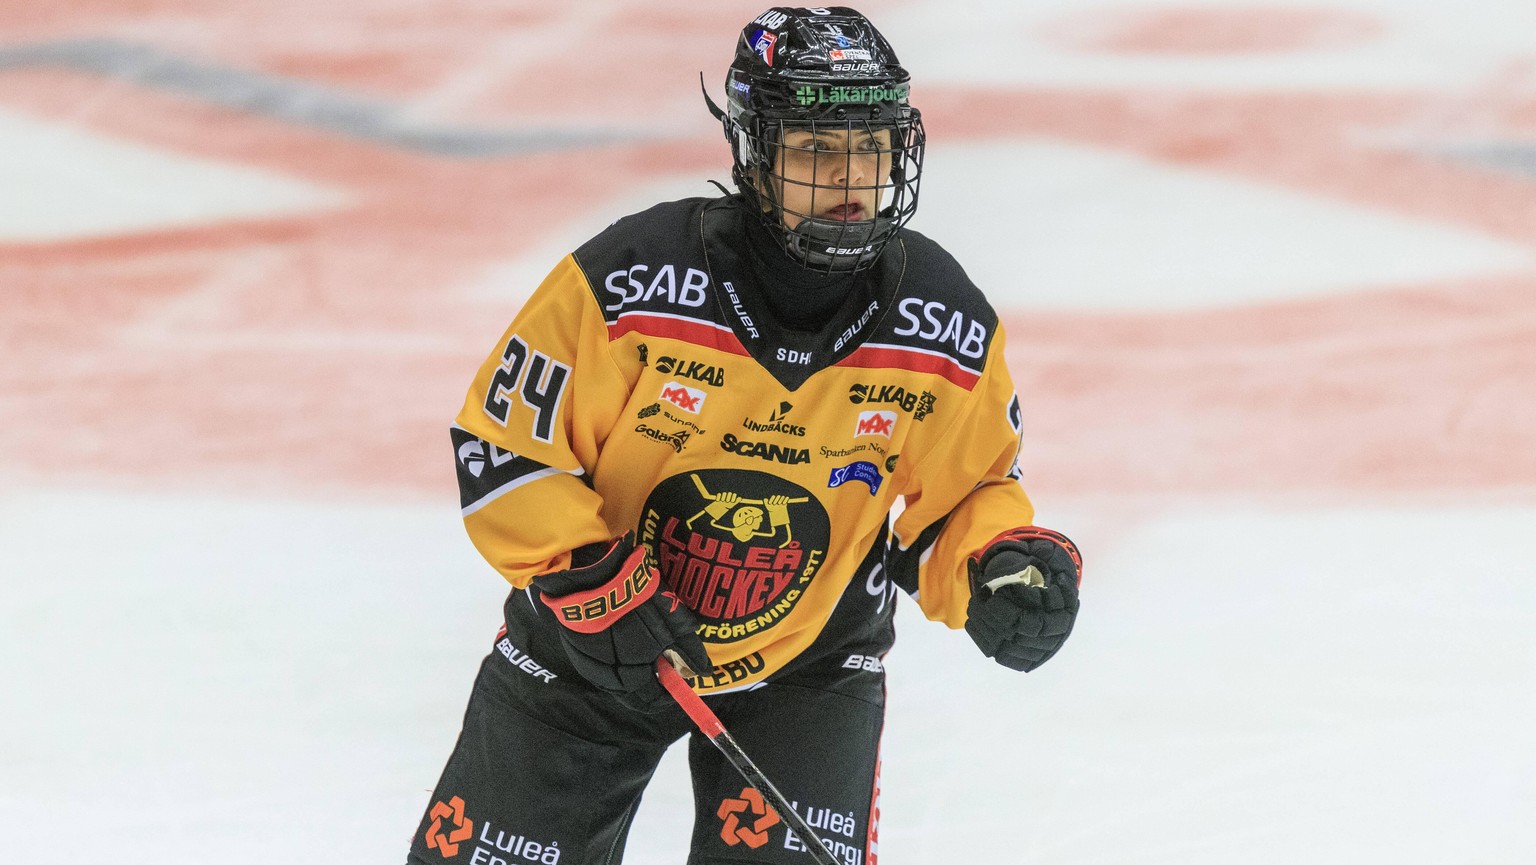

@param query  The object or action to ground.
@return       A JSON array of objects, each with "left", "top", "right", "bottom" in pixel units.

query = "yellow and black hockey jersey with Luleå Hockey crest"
[{"left": 453, "top": 197, "right": 1034, "bottom": 691}]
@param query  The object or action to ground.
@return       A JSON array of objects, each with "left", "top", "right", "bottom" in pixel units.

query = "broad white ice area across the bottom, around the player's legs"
[{"left": 0, "top": 493, "right": 1536, "bottom": 865}]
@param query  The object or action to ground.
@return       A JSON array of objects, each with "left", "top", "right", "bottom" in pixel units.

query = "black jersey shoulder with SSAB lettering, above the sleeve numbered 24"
[{"left": 573, "top": 198, "right": 717, "bottom": 326}]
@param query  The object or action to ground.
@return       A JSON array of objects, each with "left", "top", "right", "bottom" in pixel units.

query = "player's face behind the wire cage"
[{"left": 773, "top": 124, "right": 891, "bottom": 230}]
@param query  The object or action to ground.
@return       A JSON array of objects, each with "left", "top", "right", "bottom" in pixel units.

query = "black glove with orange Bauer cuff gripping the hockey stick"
[{"left": 533, "top": 532, "right": 713, "bottom": 710}]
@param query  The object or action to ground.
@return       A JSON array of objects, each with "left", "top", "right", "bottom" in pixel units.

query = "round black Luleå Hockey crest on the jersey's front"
[{"left": 641, "top": 469, "right": 831, "bottom": 642}]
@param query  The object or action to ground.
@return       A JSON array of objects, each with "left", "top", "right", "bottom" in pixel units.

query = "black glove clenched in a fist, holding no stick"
[{"left": 965, "top": 525, "right": 1083, "bottom": 673}]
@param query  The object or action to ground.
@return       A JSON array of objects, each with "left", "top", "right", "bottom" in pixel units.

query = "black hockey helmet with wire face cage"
[{"left": 705, "top": 6, "right": 925, "bottom": 272}]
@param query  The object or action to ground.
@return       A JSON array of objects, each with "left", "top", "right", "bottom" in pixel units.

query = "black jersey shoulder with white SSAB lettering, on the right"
[{"left": 865, "top": 229, "right": 997, "bottom": 381}]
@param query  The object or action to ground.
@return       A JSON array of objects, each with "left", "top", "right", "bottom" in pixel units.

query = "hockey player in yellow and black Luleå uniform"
[{"left": 410, "top": 8, "right": 1080, "bottom": 865}]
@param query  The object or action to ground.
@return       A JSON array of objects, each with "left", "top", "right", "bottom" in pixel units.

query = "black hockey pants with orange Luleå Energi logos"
[{"left": 409, "top": 593, "right": 892, "bottom": 865}]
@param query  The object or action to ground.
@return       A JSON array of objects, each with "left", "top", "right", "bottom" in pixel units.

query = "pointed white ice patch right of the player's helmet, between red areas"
[{"left": 914, "top": 138, "right": 1536, "bottom": 309}]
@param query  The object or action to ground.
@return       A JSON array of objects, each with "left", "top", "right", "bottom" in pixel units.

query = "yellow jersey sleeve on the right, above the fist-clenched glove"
[{"left": 888, "top": 326, "right": 1035, "bottom": 628}]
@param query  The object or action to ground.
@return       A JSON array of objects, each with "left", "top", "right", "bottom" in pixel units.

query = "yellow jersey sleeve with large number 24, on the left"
[{"left": 452, "top": 255, "right": 633, "bottom": 588}]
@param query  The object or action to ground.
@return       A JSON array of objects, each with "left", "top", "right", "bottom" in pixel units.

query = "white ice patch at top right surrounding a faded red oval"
[{"left": 871, "top": 0, "right": 1536, "bottom": 94}]
